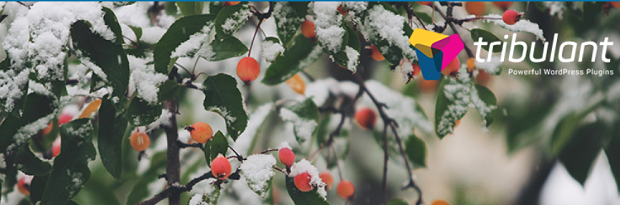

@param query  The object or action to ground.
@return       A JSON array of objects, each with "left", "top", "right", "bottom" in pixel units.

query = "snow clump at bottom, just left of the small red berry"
[{"left": 239, "top": 154, "right": 276, "bottom": 199}]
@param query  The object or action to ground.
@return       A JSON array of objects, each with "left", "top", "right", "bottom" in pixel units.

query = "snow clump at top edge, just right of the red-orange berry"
[{"left": 313, "top": 2, "right": 345, "bottom": 53}]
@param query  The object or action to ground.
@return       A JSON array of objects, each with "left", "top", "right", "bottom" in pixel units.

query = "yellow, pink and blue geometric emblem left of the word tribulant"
[{"left": 409, "top": 28, "right": 465, "bottom": 80}]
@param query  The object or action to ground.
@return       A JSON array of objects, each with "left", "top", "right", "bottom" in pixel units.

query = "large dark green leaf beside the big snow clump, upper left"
[{"left": 71, "top": 21, "right": 129, "bottom": 102}]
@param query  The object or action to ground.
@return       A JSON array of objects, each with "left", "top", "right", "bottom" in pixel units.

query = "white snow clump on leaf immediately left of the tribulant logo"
[{"left": 359, "top": 4, "right": 417, "bottom": 61}]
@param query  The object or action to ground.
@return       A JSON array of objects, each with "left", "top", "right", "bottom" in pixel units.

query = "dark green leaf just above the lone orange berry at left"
[{"left": 127, "top": 97, "right": 163, "bottom": 126}]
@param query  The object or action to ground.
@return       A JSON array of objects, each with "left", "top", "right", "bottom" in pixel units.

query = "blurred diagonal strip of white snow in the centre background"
[{"left": 234, "top": 103, "right": 273, "bottom": 154}]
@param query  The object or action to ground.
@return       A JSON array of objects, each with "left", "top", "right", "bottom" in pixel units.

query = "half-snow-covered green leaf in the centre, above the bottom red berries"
[{"left": 280, "top": 98, "right": 319, "bottom": 144}]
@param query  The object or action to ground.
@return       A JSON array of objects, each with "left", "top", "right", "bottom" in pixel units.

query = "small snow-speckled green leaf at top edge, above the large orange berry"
[{"left": 215, "top": 2, "right": 252, "bottom": 38}]
